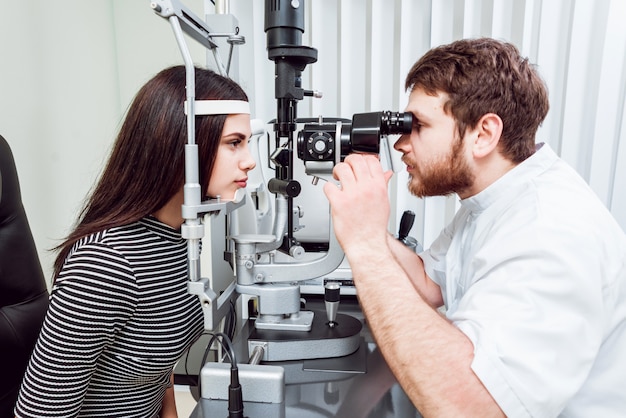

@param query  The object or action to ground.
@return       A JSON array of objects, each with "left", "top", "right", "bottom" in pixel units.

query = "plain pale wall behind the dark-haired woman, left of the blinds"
[{"left": 0, "top": 0, "right": 205, "bottom": 282}]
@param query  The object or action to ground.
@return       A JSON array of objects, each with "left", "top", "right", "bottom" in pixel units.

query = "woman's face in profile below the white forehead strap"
[{"left": 207, "top": 114, "right": 256, "bottom": 200}]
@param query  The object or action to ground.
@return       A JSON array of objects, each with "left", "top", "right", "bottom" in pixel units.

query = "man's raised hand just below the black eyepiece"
[{"left": 324, "top": 154, "right": 393, "bottom": 254}]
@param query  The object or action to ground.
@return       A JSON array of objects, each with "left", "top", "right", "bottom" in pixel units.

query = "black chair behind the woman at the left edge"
[{"left": 0, "top": 136, "right": 48, "bottom": 418}]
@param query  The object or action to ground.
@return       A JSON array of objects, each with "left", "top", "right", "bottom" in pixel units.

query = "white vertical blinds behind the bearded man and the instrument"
[{"left": 231, "top": 0, "right": 626, "bottom": 245}]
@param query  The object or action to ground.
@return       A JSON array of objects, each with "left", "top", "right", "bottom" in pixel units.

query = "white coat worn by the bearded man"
[{"left": 420, "top": 144, "right": 626, "bottom": 418}]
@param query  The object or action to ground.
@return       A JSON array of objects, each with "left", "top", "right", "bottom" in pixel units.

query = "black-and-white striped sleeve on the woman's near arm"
[{"left": 16, "top": 244, "right": 137, "bottom": 417}]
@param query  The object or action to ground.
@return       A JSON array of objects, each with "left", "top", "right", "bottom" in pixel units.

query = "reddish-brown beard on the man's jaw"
[{"left": 407, "top": 139, "right": 474, "bottom": 197}]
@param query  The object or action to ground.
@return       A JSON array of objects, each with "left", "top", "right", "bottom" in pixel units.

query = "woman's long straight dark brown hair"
[{"left": 53, "top": 66, "right": 248, "bottom": 278}]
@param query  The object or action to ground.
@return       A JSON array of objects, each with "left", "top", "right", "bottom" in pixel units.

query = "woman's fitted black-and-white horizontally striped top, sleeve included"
[{"left": 16, "top": 217, "right": 203, "bottom": 417}]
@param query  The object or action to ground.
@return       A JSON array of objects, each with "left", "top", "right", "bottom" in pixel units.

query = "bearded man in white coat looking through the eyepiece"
[{"left": 324, "top": 39, "right": 626, "bottom": 417}]
